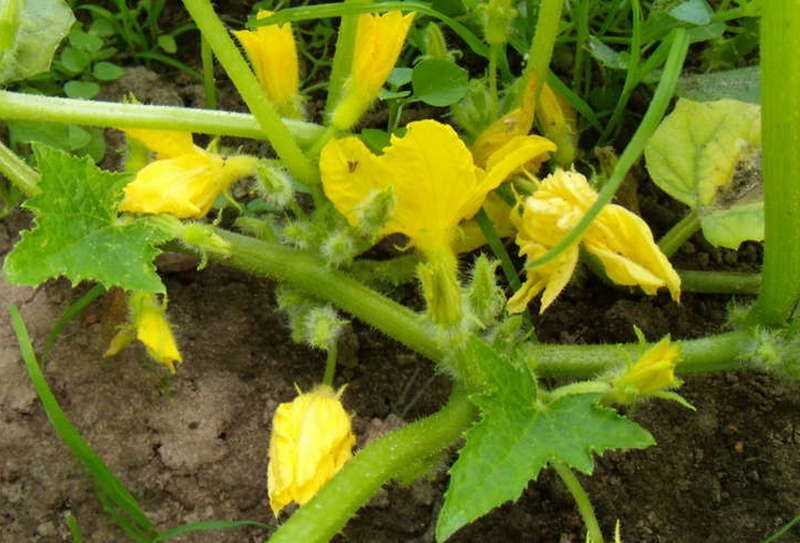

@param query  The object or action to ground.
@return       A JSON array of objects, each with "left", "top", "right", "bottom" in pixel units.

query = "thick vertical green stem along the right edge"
[{"left": 753, "top": 0, "right": 800, "bottom": 326}]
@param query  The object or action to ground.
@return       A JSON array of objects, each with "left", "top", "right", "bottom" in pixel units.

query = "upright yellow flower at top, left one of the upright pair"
[{"left": 234, "top": 10, "right": 302, "bottom": 118}]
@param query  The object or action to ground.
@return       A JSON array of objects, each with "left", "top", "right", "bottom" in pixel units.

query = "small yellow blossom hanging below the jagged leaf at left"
[{"left": 104, "top": 292, "right": 183, "bottom": 373}]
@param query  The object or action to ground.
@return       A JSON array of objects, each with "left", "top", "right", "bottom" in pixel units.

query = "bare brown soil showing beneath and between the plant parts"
[{"left": 0, "top": 6, "right": 800, "bottom": 543}]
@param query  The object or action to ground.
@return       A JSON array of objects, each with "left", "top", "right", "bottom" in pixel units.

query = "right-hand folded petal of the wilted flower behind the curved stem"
[{"left": 583, "top": 204, "right": 681, "bottom": 302}]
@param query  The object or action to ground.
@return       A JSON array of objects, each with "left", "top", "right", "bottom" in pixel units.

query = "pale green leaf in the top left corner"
[{"left": 0, "top": 0, "right": 75, "bottom": 84}]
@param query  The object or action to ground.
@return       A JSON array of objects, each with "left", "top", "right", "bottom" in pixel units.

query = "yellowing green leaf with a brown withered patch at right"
[{"left": 645, "top": 99, "right": 764, "bottom": 248}]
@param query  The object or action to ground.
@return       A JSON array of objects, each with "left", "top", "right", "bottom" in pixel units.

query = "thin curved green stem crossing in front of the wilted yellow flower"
[{"left": 527, "top": 28, "right": 689, "bottom": 268}]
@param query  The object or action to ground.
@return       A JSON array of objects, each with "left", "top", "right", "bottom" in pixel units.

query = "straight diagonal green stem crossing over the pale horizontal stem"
[{"left": 183, "top": 0, "right": 319, "bottom": 185}]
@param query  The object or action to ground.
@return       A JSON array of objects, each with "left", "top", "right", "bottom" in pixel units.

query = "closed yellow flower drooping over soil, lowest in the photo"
[{"left": 267, "top": 385, "right": 356, "bottom": 516}]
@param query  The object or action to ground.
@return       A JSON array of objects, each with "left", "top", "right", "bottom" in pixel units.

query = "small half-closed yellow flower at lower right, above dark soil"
[{"left": 611, "top": 336, "right": 681, "bottom": 404}]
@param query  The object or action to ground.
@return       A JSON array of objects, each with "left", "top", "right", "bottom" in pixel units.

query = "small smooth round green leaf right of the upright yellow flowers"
[{"left": 411, "top": 58, "right": 469, "bottom": 107}]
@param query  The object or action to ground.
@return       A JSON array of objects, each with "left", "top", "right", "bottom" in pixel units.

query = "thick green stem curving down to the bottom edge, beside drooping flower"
[{"left": 269, "top": 389, "right": 477, "bottom": 543}]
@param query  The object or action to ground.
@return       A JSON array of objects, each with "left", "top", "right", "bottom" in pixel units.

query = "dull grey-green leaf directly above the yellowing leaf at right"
[{"left": 675, "top": 66, "right": 761, "bottom": 104}]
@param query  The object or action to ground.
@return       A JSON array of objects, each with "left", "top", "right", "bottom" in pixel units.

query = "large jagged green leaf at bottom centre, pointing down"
[{"left": 436, "top": 339, "right": 655, "bottom": 541}]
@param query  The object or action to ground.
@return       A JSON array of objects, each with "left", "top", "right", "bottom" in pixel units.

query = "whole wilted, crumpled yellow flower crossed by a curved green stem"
[{"left": 508, "top": 170, "right": 681, "bottom": 313}]
